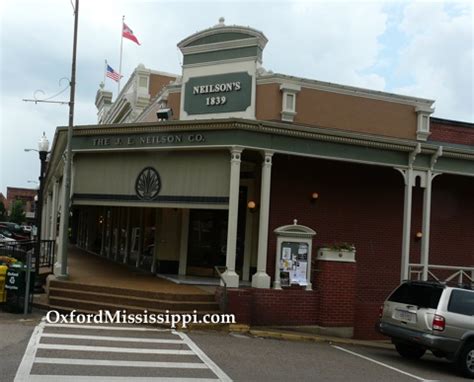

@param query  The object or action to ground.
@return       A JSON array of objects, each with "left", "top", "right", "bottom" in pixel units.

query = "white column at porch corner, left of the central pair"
[{"left": 222, "top": 147, "right": 242, "bottom": 288}]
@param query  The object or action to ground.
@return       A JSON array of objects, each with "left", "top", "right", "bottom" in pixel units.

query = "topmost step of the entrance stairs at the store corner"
[{"left": 48, "top": 280, "right": 215, "bottom": 302}]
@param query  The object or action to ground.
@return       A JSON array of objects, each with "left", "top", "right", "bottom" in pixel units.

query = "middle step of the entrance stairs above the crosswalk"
[{"left": 49, "top": 287, "right": 219, "bottom": 312}]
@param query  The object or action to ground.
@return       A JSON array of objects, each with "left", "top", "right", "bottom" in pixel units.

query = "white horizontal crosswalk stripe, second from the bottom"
[{"left": 35, "top": 357, "right": 208, "bottom": 369}]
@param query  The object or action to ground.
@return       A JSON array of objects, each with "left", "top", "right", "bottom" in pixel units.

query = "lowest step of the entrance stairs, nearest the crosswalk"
[{"left": 48, "top": 296, "right": 220, "bottom": 317}]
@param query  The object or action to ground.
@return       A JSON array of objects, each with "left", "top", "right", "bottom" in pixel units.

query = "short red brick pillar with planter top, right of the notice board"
[{"left": 313, "top": 256, "right": 357, "bottom": 328}]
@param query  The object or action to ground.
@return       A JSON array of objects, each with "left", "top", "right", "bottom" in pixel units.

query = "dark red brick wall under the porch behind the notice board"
[{"left": 267, "top": 155, "right": 474, "bottom": 338}]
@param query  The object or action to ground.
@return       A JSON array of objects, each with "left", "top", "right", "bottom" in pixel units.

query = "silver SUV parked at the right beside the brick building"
[{"left": 376, "top": 281, "right": 474, "bottom": 378}]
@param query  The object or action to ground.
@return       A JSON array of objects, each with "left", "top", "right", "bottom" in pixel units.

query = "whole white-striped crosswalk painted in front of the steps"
[{"left": 15, "top": 321, "right": 232, "bottom": 382}]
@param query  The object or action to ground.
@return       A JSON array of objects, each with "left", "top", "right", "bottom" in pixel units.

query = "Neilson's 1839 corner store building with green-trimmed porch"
[{"left": 43, "top": 22, "right": 474, "bottom": 338}]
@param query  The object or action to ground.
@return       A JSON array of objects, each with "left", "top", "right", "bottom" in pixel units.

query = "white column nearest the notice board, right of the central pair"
[{"left": 252, "top": 152, "right": 273, "bottom": 288}]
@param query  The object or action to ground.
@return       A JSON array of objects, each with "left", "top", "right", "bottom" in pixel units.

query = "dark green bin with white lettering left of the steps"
[{"left": 5, "top": 266, "right": 35, "bottom": 313}]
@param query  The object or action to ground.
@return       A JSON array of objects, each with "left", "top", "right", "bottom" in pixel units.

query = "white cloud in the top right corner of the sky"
[{"left": 394, "top": 2, "right": 474, "bottom": 121}]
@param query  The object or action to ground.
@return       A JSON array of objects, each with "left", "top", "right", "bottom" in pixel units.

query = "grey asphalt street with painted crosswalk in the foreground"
[{"left": 0, "top": 315, "right": 466, "bottom": 382}]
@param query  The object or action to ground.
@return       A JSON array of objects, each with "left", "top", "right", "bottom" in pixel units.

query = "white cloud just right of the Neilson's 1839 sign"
[{"left": 266, "top": 2, "right": 388, "bottom": 90}]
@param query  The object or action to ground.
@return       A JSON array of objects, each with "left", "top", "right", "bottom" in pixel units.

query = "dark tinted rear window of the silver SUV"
[{"left": 388, "top": 284, "right": 443, "bottom": 309}]
